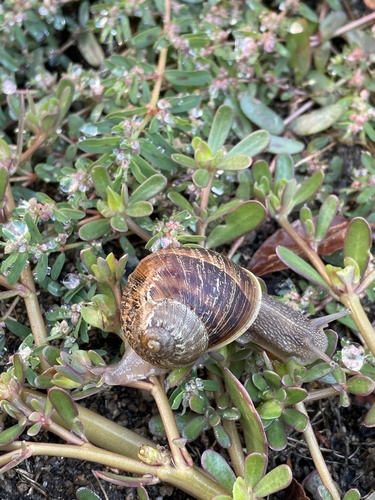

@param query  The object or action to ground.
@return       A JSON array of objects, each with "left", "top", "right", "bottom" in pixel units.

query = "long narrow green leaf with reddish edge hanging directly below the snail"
[{"left": 224, "top": 368, "right": 267, "bottom": 455}]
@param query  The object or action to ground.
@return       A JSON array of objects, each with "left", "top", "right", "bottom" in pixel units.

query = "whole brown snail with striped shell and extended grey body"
[{"left": 100, "top": 247, "right": 348, "bottom": 384}]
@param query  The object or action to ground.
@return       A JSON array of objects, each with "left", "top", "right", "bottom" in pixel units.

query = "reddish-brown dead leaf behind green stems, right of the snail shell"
[{"left": 248, "top": 215, "right": 349, "bottom": 276}]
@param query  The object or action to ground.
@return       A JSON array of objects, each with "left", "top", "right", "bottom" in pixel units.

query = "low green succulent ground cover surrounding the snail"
[{"left": 0, "top": 0, "right": 375, "bottom": 500}]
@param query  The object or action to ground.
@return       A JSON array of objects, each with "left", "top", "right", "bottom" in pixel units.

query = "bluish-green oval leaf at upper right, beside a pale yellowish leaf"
[{"left": 240, "top": 95, "right": 285, "bottom": 135}]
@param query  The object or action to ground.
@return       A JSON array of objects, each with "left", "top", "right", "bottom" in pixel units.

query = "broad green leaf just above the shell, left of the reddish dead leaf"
[{"left": 207, "top": 201, "right": 266, "bottom": 248}]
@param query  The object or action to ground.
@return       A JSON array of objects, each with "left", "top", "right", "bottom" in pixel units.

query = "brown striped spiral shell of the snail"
[{"left": 121, "top": 248, "right": 262, "bottom": 368}]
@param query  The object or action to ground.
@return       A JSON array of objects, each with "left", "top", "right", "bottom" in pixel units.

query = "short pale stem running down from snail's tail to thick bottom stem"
[{"left": 150, "top": 377, "right": 193, "bottom": 470}]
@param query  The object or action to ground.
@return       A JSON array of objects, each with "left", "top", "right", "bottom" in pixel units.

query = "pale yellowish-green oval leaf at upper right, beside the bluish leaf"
[{"left": 290, "top": 102, "right": 345, "bottom": 136}]
